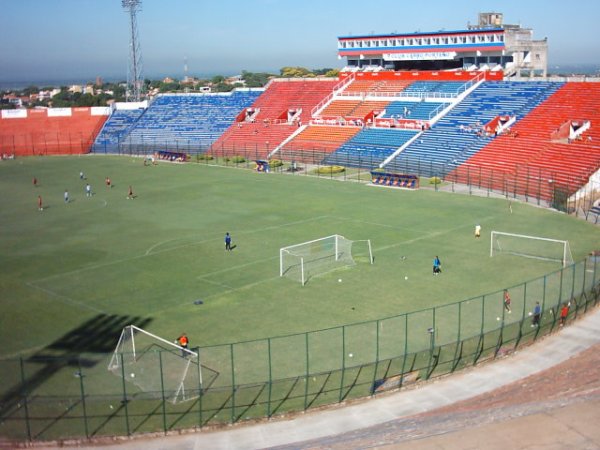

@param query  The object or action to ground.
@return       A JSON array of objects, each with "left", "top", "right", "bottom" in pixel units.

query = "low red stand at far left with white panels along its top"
[{"left": 0, "top": 108, "right": 108, "bottom": 156}]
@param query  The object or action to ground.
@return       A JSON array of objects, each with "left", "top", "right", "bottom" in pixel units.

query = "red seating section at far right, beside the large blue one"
[{"left": 451, "top": 82, "right": 600, "bottom": 199}]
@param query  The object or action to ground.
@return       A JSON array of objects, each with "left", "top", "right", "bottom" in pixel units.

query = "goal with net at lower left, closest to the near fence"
[{"left": 108, "top": 325, "right": 202, "bottom": 403}]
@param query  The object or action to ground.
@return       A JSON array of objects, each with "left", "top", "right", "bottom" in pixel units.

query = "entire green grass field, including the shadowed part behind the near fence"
[{"left": 0, "top": 156, "right": 600, "bottom": 439}]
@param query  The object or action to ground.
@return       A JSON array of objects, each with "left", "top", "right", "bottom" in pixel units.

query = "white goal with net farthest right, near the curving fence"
[{"left": 490, "top": 231, "right": 573, "bottom": 267}]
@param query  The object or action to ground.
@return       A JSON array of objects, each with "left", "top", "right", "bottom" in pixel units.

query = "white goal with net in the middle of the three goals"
[{"left": 279, "top": 234, "right": 373, "bottom": 286}]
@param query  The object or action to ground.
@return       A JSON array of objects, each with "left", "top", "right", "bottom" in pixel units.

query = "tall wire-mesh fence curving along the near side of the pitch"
[{"left": 0, "top": 256, "right": 600, "bottom": 444}]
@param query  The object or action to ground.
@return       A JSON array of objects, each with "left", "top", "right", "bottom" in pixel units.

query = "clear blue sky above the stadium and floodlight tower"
[{"left": 0, "top": 0, "right": 600, "bottom": 81}]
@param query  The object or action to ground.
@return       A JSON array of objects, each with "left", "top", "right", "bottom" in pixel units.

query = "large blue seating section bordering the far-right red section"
[{"left": 386, "top": 81, "right": 561, "bottom": 176}]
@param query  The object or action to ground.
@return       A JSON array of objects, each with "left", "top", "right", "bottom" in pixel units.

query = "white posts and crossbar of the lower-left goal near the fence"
[{"left": 108, "top": 325, "right": 203, "bottom": 403}]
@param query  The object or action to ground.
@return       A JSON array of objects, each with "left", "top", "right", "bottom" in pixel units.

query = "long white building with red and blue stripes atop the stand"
[{"left": 338, "top": 12, "right": 548, "bottom": 77}]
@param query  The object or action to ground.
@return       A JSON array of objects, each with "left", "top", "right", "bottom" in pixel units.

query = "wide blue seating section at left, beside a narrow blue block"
[{"left": 121, "top": 90, "right": 261, "bottom": 150}]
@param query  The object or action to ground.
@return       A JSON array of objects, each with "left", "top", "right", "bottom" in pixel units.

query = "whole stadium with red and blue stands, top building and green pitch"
[{"left": 0, "top": 8, "right": 600, "bottom": 445}]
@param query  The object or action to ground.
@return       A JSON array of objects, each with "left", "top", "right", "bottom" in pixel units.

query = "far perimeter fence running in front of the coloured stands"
[{"left": 88, "top": 139, "right": 600, "bottom": 219}]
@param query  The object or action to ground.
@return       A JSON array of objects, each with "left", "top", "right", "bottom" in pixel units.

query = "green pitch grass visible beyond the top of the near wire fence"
[{"left": 0, "top": 156, "right": 600, "bottom": 357}]
